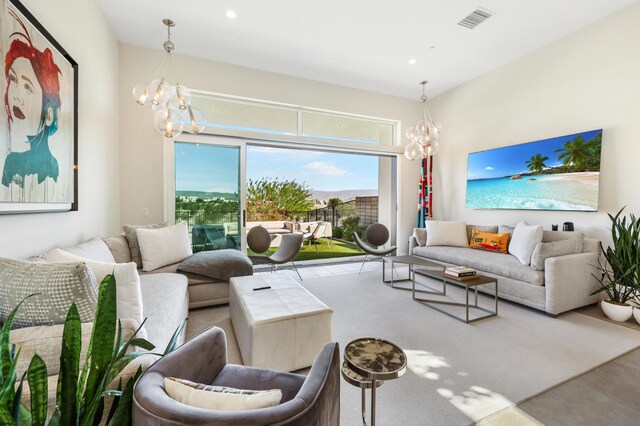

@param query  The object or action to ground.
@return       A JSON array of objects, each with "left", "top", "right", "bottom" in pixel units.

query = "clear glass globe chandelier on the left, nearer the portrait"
[{"left": 133, "top": 19, "right": 205, "bottom": 138}]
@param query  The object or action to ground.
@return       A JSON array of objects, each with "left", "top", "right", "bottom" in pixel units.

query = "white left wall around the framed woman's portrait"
[{"left": 0, "top": 0, "right": 120, "bottom": 257}]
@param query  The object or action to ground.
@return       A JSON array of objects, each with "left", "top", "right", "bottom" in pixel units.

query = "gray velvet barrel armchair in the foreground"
[{"left": 133, "top": 327, "right": 340, "bottom": 426}]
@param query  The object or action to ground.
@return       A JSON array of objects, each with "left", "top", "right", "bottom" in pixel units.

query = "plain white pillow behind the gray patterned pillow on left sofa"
[{"left": 47, "top": 249, "right": 147, "bottom": 339}]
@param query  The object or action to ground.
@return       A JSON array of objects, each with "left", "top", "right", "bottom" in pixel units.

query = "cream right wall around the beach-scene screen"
[{"left": 431, "top": 3, "right": 640, "bottom": 240}]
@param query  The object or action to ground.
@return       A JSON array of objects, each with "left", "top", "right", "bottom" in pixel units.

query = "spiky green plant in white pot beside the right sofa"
[{"left": 592, "top": 207, "right": 640, "bottom": 321}]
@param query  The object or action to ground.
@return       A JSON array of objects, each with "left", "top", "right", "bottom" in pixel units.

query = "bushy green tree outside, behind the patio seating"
[{"left": 247, "top": 178, "right": 313, "bottom": 221}]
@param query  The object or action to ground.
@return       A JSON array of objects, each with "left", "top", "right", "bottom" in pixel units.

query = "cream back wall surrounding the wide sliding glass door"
[{"left": 119, "top": 45, "right": 420, "bottom": 253}]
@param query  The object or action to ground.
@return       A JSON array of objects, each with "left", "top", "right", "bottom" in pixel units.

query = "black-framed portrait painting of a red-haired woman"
[{"left": 0, "top": 0, "right": 78, "bottom": 213}]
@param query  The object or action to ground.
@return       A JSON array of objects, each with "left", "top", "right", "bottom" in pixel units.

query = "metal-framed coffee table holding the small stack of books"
[{"left": 413, "top": 268, "right": 498, "bottom": 324}]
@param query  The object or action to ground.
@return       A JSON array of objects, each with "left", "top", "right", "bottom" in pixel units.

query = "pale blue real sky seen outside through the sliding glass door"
[{"left": 175, "top": 142, "right": 378, "bottom": 192}]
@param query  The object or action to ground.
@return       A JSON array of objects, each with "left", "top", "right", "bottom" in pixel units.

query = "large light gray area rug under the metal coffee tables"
[{"left": 298, "top": 271, "right": 640, "bottom": 425}]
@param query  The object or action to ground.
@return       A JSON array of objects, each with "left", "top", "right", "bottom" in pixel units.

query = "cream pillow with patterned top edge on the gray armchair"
[{"left": 164, "top": 377, "right": 282, "bottom": 411}]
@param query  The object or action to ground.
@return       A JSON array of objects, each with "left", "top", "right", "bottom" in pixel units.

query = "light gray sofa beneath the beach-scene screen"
[{"left": 409, "top": 225, "right": 600, "bottom": 316}]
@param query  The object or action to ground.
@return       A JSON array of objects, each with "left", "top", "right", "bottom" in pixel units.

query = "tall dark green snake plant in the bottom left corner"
[{"left": 0, "top": 275, "right": 187, "bottom": 426}]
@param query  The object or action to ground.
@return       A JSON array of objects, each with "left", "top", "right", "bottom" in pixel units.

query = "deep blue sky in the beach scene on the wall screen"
[{"left": 467, "top": 129, "right": 602, "bottom": 180}]
